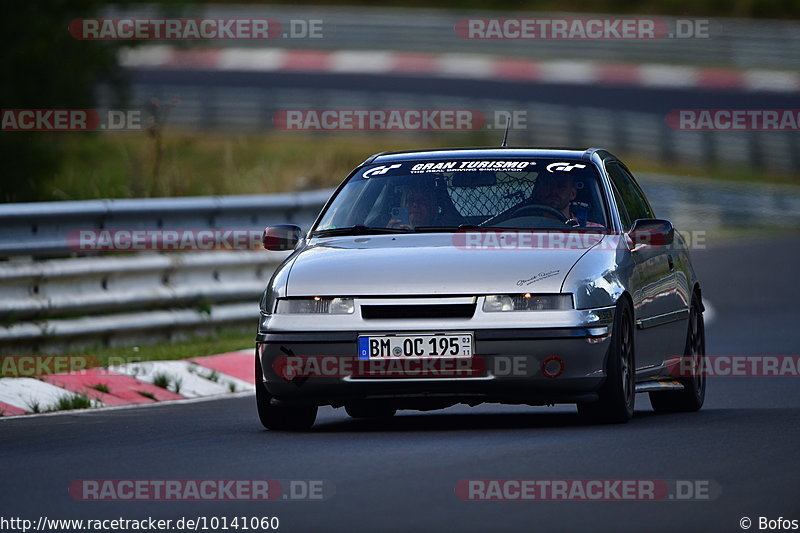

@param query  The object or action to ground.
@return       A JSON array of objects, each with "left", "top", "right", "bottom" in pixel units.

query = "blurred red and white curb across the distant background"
[{"left": 120, "top": 45, "right": 800, "bottom": 92}]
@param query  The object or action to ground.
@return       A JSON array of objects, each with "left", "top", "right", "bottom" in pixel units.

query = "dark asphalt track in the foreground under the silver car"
[{"left": 0, "top": 238, "right": 800, "bottom": 532}]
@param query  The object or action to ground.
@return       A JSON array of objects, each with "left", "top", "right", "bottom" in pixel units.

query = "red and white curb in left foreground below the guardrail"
[{"left": 0, "top": 350, "right": 255, "bottom": 418}]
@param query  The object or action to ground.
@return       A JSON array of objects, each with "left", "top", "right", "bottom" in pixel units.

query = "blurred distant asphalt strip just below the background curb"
[{"left": 127, "top": 69, "right": 800, "bottom": 114}]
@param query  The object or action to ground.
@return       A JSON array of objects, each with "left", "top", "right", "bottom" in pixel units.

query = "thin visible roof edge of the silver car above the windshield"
[{"left": 364, "top": 147, "right": 616, "bottom": 164}]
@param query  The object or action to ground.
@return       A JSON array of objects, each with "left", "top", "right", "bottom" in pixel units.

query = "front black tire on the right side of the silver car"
[{"left": 578, "top": 298, "right": 636, "bottom": 424}]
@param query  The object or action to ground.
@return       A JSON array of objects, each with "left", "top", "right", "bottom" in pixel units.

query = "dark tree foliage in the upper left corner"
[{"left": 0, "top": 0, "right": 128, "bottom": 202}]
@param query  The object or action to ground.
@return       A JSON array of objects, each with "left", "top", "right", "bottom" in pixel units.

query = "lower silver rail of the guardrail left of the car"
[{"left": 0, "top": 250, "right": 286, "bottom": 319}]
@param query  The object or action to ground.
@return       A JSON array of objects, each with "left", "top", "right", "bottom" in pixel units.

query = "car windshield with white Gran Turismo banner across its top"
[{"left": 314, "top": 158, "right": 608, "bottom": 234}]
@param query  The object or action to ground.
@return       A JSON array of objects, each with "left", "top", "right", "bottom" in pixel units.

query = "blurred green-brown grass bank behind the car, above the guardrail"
[{"left": 34, "top": 129, "right": 797, "bottom": 200}]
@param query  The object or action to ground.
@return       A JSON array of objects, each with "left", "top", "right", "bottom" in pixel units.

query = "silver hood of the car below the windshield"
[{"left": 286, "top": 233, "right": 603, "bottom": 296}]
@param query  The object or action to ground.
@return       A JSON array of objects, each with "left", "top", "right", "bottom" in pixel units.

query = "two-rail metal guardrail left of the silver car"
[{"left": 0, "top": 190, "right": 331, "bottom": 353}]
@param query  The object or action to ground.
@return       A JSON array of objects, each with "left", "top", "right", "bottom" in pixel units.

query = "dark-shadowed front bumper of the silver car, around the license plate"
[{"left": 256, "top": 320, "right": 611, "bottom": 409}]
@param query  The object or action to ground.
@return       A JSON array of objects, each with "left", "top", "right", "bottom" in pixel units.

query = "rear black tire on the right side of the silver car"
[{"left": 650, "top": 293, "right": 706, "bottom": 413}]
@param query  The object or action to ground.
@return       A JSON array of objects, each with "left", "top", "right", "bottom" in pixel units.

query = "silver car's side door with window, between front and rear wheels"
[{"left": 606, "top": 162, "right": 686, "bottom": 370}]
